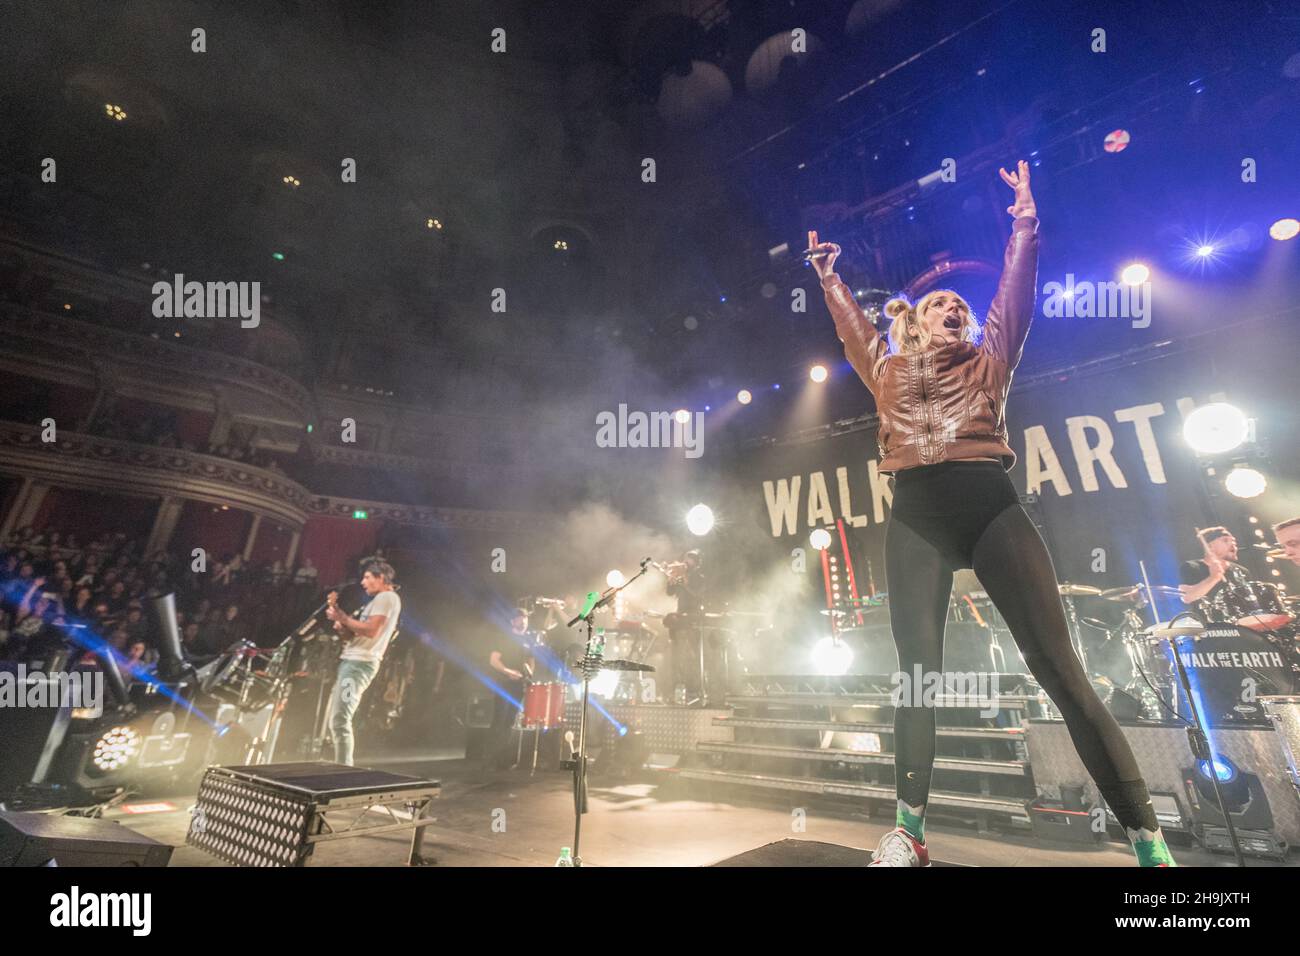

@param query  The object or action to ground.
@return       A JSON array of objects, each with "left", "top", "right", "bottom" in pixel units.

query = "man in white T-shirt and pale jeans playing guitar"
[{"left": 325, "top": 559, "right": 402, "bottom": 766}]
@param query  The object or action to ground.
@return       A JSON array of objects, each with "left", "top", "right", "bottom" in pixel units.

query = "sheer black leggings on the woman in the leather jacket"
[{"left": 885, "top": 462, "right": 1157, "bottom": 831}]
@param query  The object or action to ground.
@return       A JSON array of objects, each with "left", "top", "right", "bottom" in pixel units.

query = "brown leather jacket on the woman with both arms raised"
[{"left": 822, "top": 216, "right": 1039, "bottom": 473}]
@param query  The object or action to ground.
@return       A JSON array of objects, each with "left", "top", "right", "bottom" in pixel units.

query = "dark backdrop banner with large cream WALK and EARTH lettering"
[{"left": 727, "top": 319, "right": 1300, "bottom": 610}]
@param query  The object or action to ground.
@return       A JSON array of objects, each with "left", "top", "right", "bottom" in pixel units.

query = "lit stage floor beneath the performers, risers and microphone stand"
[{"left": 105, "top": 754, "right": 1300, "bottom": 866}]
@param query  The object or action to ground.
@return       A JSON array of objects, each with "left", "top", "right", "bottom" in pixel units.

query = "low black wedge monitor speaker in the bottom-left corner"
[{"left": 0, "top": 810, "right": 172, "bottom": 866}]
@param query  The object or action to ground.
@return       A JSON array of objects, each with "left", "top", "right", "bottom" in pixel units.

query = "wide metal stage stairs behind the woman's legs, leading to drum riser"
[{"left": 673, "top": 675, "right": 1041, "bottom": 829}]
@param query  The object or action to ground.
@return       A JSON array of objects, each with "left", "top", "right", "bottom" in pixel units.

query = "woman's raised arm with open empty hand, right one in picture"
[{"left": 982, "top": 160, "right": 1039, "bottom": 368}]
